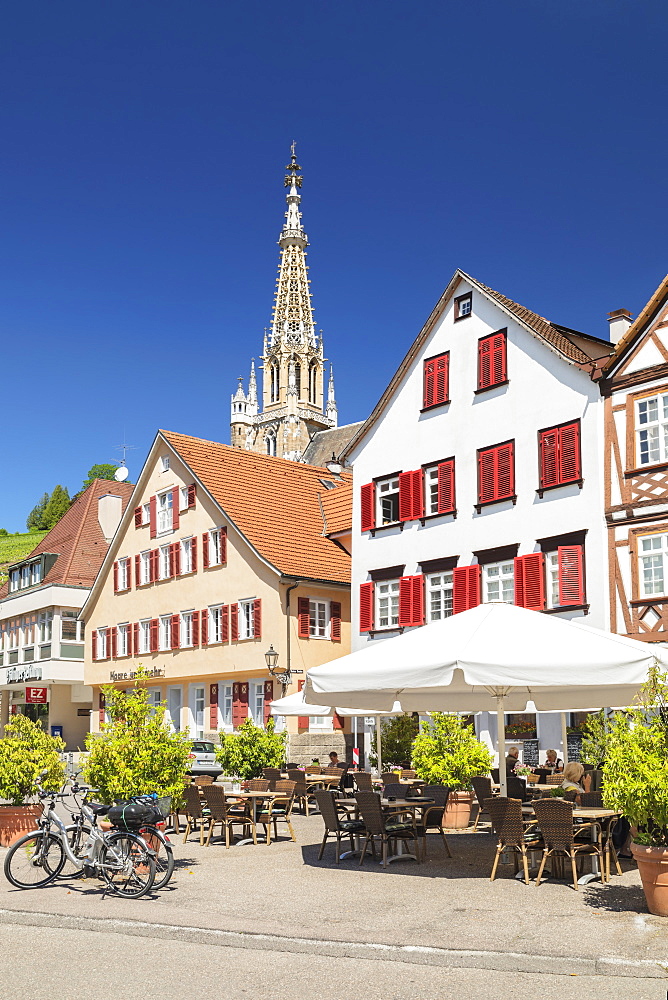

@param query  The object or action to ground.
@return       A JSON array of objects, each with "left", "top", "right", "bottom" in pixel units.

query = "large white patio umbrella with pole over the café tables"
[{"left": 304, "top": 603, "right": 668, "bottom": 794}]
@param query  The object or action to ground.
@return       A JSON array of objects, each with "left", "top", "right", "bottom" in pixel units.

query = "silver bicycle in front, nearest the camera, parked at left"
[{"left": 4, "top": 784, "right": 156, "bottom": 899}]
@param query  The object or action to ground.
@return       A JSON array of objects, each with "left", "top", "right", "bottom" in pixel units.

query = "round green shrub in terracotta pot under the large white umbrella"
[{"left": 413, "top": 712, "right": 492, "bottom": 830}]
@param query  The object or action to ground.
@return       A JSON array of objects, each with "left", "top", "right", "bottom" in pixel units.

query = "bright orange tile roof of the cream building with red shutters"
[{"left": 160, "top": 431, "right": 352, "bottom": 583}]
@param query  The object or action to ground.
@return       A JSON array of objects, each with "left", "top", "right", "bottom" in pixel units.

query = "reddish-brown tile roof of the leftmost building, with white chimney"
[{"left": 0, "top": 479, "right": 134, "bottom": 600}]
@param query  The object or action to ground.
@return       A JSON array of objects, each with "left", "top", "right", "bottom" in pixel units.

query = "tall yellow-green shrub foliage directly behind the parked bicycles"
[{"left": 83, "top": 664, "right": 192, "bottom": 802}]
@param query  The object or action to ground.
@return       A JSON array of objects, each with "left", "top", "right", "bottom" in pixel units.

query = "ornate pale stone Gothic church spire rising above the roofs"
[{"left": 230, "top": 142, "right": 337, "bottom": 461}]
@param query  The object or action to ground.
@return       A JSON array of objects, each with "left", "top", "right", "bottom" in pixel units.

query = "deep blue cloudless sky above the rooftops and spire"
[{"left": 0, "top": 0, "right": 668, "bottom": 531}]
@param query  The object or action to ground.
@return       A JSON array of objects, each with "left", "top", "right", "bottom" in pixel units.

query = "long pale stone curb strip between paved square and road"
[{"left": 0, "top": 909, "right": 668, "bottom": 979}]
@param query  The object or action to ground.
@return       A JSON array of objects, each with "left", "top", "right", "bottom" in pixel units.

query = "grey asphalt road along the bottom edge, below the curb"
[{"left": 0, "top": 924, "right": 666, "bottom": 1000}]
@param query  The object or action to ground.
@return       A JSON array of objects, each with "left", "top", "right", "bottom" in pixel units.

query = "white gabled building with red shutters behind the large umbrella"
[{"left": 342, "top": 271, "right": 612, "bottom": 749}]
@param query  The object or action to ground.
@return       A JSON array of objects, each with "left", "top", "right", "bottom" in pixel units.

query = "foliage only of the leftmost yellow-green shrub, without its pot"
[{"left": 0, "top": 715, "right": 65, "bottom": 806}]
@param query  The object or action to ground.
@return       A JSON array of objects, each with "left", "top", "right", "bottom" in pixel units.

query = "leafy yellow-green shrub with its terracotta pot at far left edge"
[{"left": 0, "top": 715, "right": 65, "bottom": 847}]
